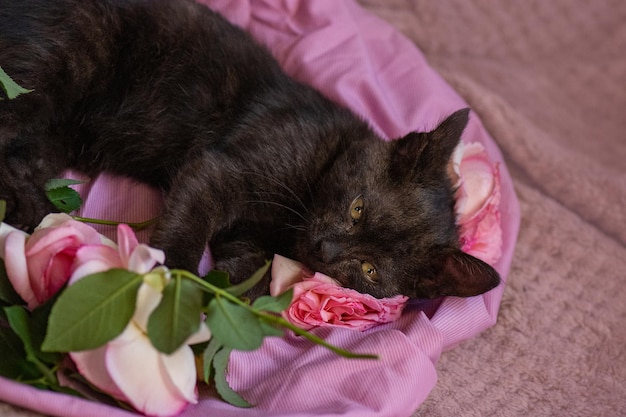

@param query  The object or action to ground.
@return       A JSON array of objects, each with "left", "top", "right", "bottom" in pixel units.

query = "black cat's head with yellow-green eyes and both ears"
[{"left": 297, "top": 109, "right": 500, "bottom": 298}]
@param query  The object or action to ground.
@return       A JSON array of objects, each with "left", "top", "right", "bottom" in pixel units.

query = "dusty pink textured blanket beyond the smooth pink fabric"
[{"left": 360, "top": 0, "right": 626, "bottom": 417}]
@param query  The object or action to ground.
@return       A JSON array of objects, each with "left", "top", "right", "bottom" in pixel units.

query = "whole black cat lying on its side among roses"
[{"left": 0, "top": 0, "right": 499, "bottom": 297}]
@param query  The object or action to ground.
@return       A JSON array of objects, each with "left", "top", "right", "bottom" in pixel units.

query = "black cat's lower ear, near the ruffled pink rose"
[{"left": 418, "top": 248, "right": 500, "bottom": 298}]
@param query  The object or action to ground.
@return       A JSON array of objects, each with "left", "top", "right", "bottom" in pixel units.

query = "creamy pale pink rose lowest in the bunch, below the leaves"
[{"left": 70, "top": 274, "right": 211, "bottom": 416}]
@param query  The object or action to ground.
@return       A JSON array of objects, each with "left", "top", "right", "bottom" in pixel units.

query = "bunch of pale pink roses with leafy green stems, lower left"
[{"left": 0, "top": 208, "right": 380, "bottom": 415}]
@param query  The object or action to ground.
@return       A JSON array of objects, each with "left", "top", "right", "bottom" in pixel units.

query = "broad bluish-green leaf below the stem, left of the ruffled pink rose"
[{"left": 206, "top": 296, "right": 263, "bottom": 350}]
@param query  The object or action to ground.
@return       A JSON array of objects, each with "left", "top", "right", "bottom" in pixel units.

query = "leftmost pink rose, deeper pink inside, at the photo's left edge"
[{"left": 0, "top": 214, "right": 106, "bottom": 309}]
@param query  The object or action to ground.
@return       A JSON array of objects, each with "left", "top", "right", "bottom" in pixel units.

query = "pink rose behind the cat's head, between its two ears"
[{"left": 452, "top": 142, "right": 502, "bottom": 265}]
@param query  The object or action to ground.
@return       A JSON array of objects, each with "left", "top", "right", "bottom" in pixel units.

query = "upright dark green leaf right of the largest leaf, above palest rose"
[{"left": 148, "top": 276, "right": 203, "bottom": 354}]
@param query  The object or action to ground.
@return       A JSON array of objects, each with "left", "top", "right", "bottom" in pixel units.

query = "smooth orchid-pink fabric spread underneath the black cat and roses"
[{"left": 0, "top": 0, "right": 519, "bottom": 417}]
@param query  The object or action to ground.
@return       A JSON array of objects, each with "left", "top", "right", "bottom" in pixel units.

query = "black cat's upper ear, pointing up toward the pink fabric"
[{"left": 390, "top": 108, "right": 469, "bottom": 177}]
